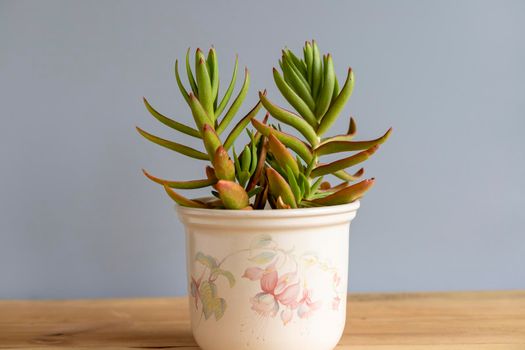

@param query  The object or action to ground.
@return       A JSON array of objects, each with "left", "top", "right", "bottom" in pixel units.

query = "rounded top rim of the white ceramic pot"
[{"left": 175, "top": 200, "right": 361, "bottom": 219}]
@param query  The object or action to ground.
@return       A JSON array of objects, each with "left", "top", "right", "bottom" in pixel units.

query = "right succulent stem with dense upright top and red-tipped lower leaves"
[{"left": 252, "top": 41, "right": 392, "bottom": 208}]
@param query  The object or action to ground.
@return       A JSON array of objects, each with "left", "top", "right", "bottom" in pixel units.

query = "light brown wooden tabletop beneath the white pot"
[{"left": 0, "top": 291, "right": 525, "bottom": 350}]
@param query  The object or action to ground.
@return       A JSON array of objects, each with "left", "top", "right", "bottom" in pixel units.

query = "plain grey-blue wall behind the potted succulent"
[{"left": 0, "top": 1, "right": 525, "bottom": 298}]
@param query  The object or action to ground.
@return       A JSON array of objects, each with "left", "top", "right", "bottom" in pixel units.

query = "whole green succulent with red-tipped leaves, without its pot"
[{"left": 137, "top": 41, "right": 392, "bottom": 209}]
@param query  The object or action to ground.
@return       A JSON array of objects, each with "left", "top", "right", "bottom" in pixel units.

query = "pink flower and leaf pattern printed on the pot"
[{"left": 190, "top": 234, "right": 344, "bottom": 325}]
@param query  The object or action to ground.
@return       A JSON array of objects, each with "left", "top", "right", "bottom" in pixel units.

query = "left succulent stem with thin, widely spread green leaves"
[{"left": 137, "top": 47, "right": 263, "bottom": 209}]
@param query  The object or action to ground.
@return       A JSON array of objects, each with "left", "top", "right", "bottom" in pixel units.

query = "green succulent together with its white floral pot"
[{"left": 137, "top": 41, "right": 391, "bottom": 350}]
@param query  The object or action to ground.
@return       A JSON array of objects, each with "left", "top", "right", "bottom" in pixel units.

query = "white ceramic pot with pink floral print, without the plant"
[{"left": 177, "top": 201, "right": 359, "bottom": 350}]
